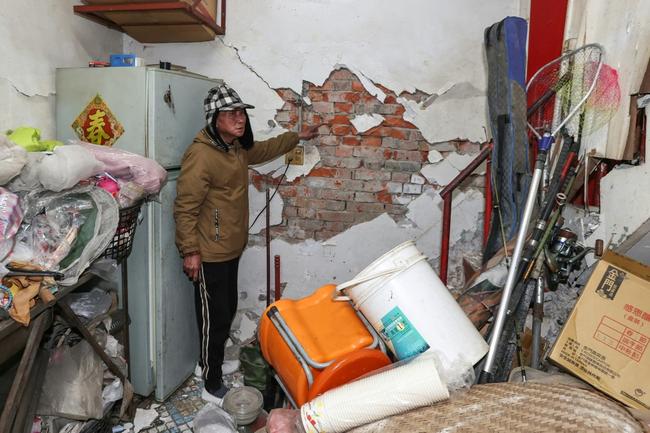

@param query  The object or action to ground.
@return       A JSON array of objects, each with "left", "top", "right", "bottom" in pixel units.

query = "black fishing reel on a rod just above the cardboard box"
[{"left": 544, "top": 228, "right": 603, "bottom": 291}]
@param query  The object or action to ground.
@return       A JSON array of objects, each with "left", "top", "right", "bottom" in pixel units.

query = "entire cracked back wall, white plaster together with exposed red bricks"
[{"left": 124, "top": 0, "right": 526, "bottom": 340}]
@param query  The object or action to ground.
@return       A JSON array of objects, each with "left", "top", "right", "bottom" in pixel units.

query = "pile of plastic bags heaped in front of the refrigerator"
[{"left": 0, "top": 127, "right": 167, "bottom": 323}]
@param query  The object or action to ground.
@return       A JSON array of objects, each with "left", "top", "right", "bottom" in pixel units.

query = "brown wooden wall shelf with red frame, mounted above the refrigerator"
[{"left": 77, "top": 0, "right": 224, "bottom": 43}]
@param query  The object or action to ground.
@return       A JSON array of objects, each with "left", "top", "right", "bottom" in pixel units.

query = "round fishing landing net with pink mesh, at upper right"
[{"left": 526, "top": 44, "right": 621, "bottom": 140}]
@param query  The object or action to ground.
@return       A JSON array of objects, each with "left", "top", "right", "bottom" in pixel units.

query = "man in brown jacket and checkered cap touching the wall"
[{"left": 174, "top": 85, "right": 318, "bottom": 403}]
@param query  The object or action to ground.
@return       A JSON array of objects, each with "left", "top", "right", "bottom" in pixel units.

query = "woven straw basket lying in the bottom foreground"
[{"left": 350, "top": 382, "right": 645, "bottom": 433}]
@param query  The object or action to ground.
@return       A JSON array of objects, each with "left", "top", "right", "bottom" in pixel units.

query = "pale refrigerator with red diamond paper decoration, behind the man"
[{"left": 56, "top": 67, "right": 221, "bottom": 401}]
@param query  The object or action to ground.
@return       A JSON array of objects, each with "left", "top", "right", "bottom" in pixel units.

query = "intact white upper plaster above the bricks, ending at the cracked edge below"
[{"left": 220, "top": 0, "right": 519, "bottom": 94}]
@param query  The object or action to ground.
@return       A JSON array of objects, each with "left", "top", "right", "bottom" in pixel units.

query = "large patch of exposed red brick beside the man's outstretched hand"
[{"left": 264, "top": 68, "right": 436, "bottom": 245}]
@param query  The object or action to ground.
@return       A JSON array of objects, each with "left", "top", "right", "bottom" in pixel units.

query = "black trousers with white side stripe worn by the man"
[{"left": 194, "top": 257, "right": 239, "bottom": 393}]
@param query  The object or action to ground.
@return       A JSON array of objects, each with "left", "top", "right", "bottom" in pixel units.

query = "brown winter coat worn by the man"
[{"left": 174, "top": 130, "right": 299, "bottom": 262}]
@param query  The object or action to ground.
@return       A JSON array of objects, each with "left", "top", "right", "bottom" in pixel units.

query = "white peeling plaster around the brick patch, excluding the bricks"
[{"left": 124, "top": 0, "right": 528, "bottom": 320}]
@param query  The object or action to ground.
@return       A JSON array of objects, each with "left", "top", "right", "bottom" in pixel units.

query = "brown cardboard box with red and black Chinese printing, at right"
[{"left": 549, "top": 252, "right": 650, "bottom": 410}]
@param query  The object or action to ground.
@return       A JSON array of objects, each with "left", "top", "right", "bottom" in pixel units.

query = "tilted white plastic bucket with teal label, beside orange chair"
[{"left": 337, "top": 241, "right": 488, "bottom": 374}]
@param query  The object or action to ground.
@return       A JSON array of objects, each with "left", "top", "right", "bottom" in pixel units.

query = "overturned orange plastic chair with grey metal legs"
[{"left": 258, "top": 284, "right": 391, "bottom": 407}]
